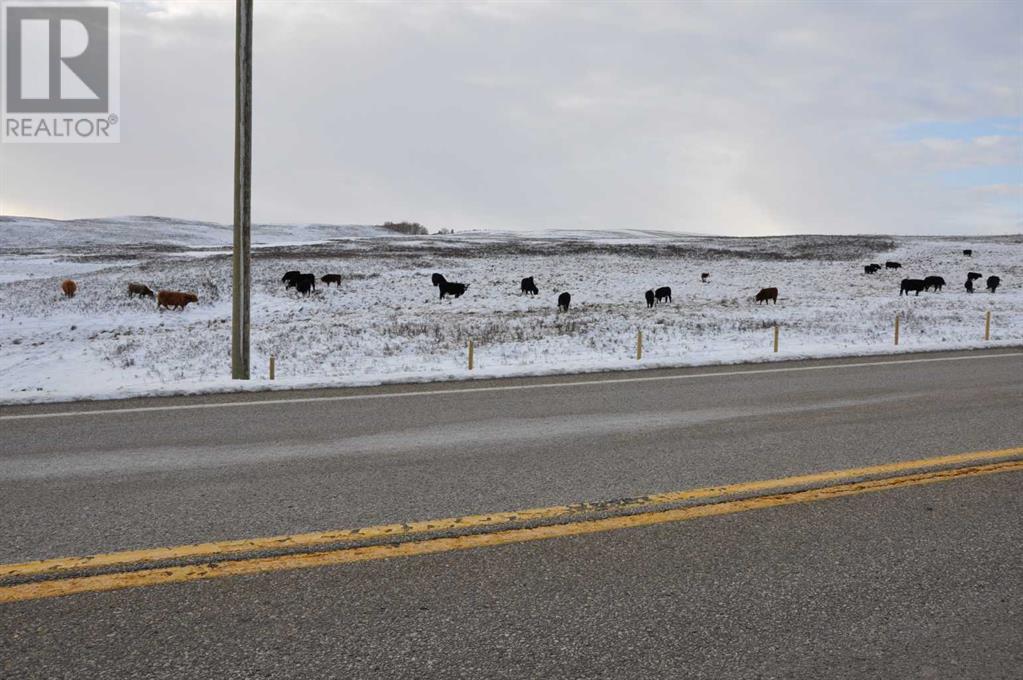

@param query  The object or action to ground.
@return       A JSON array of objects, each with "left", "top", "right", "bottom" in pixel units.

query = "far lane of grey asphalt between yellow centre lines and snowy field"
[{"left": 0, "top": 352, "right": 1023, "bottom": 561}]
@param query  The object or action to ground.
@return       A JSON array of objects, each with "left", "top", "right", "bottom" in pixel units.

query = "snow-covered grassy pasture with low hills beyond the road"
[{"left": 0, "top": 218, "right": 1023, "bottom": 403}]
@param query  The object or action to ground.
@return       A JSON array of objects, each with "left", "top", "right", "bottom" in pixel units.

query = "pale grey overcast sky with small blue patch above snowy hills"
[{"left": 0, "top": 0, "right": 1023, "bottom": 234}]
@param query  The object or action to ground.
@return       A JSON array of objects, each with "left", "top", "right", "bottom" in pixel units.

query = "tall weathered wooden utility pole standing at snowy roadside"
[{"left": 231, "top": 0, "right": 253, "bottom": 380}]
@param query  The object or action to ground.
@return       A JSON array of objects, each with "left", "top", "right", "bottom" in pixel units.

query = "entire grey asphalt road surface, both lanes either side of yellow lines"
[{"left": 0, "top": 351, "right": 1023, "bottom": 678}]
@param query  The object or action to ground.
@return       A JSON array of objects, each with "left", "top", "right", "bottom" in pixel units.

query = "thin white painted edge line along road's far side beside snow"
[{"left": 0, "top": 352, "right": 1023, "bottom": 420}]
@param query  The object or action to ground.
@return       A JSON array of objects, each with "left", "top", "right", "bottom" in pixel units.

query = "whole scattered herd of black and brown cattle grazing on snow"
[{"left": 53, "top": 250, "right": 1002, "bottom": 312}]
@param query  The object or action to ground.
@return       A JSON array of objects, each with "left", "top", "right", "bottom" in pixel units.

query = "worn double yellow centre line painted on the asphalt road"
[{"left": 0, "top": 447, "right": 1023, "bottom": 604}]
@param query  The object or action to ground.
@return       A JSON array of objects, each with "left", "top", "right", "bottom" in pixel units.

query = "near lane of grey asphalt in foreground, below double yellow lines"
[{"left": 0, "top": 473, "right": 1023, "bottom": 680}]
